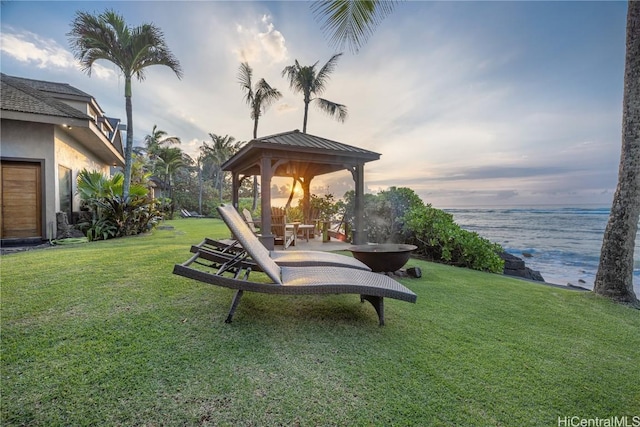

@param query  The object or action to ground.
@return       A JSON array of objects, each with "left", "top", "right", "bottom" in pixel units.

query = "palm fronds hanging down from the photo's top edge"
[{"left": 311, "top": 0, "right": 396, "bottom": 53}]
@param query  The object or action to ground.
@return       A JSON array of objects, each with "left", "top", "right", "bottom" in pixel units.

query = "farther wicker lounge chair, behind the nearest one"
[{"left": 208, "top": 205, "right": 371, "bottom": 271}]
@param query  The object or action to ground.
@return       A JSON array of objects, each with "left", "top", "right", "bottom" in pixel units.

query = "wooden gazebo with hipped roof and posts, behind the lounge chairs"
[{"left": 222, "top": 129, "right": 380, "bottom": 249}]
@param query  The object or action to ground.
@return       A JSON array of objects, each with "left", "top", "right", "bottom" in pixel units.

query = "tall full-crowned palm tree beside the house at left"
[{"left": 67, "top": 10, "right": 182, "bottom": 197}]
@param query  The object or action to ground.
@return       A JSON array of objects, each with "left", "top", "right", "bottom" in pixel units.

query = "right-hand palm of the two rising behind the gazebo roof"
[{"left": 282, "top": 53, "right": 347, "bottom": 133}]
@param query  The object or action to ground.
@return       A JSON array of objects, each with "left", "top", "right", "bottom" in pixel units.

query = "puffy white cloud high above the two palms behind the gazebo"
[{"left": 233, "top": 15, "right": 289, "bottom": 65}]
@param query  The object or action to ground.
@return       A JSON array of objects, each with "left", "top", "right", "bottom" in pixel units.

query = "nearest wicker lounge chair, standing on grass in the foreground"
[{"left": 173, "top": 206, "right": 417, "bottom": 326}]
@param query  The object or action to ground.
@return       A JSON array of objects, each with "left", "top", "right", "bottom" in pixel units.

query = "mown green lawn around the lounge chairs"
[{"left": 0, "top": 219, "right": 640, "bottom": 426}]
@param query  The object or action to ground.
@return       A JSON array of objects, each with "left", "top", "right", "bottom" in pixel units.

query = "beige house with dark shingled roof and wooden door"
[{"left": 0, "top": 74, "right": 124, "bottom": 244}]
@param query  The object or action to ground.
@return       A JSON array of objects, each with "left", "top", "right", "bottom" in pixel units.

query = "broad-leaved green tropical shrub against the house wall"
[{"left": 78, "top": 169, "right": 161, "bottom": 240}]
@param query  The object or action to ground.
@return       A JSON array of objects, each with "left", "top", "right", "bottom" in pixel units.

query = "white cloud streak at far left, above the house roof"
[{"left": 0, "top": 27, "right": 115, "bottom": 79}]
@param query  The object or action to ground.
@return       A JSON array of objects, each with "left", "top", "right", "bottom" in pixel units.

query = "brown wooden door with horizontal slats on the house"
[{"left": 0, "top": 161, "right": 42, "bottom": 239}]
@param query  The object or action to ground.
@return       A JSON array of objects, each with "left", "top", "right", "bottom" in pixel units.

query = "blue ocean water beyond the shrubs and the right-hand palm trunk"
[{"left": 445, "top": 207, "right": 640, "bottom": 297}]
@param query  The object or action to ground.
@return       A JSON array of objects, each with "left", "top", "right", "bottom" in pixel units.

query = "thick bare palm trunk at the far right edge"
[{"left": 593, "top": 1, "right": 640, "bottom": 307}]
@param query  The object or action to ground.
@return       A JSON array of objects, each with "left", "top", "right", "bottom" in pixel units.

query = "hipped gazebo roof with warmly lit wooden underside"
[{"left": 222, "top": 129, "right": 380, "bottom": 177}]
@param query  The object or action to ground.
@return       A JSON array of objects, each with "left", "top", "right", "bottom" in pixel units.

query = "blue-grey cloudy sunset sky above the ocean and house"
[{"left": 0, "top": 0, "right": 627, "bottom": 208}]
